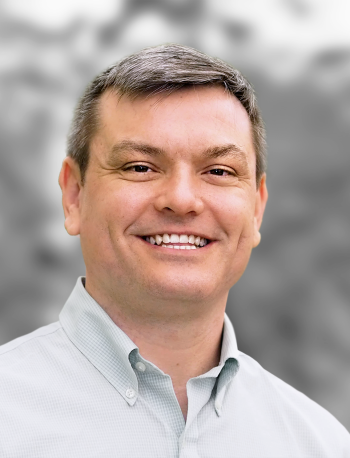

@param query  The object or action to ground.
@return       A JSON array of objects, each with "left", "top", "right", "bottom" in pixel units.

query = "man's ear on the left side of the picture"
[{"left": 58, "top": 157, "right": 83, "bottom": 235}]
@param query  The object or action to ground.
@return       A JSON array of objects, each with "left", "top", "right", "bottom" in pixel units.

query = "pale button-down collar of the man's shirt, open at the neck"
[{"left": 59, "top": 277, "right": 239, "bottom": 414}]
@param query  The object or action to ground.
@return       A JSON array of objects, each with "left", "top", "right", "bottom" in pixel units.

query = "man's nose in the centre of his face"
[{"left": 154, "top": 167, "right": 204, "bottom": 216}]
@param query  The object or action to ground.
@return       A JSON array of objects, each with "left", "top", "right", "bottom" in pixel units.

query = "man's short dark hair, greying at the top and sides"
[{"left": 67, "top": 44, "right": 266, "bottom": 183}]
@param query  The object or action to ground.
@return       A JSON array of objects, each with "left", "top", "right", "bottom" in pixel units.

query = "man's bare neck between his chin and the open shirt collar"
[{"left": 85, "top": 283, "right": 228, "bottom": 391}]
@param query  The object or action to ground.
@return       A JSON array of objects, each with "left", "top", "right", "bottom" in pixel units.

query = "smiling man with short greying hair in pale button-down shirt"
[{"left": 0, "top": 45, "right": 350, "bottom": 458}]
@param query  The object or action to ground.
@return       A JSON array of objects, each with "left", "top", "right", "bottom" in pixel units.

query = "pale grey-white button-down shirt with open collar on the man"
[{"left": 0, "top": 278, "right": 350, "bottom": 458}]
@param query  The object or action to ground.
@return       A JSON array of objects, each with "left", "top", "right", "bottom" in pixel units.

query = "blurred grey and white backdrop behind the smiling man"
[{"left": 0, "top": 0, "right": 350, "bottom": 429}]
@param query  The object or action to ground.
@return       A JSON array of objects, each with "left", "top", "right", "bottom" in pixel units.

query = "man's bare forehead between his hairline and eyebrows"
[{"left": 96, "top": 86, "right": 255, "bottom": 165}]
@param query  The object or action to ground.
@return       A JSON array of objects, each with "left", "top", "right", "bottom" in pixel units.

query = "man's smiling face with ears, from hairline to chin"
[{"left": 60, "top": 87, "right": 267, "bottom": 308}]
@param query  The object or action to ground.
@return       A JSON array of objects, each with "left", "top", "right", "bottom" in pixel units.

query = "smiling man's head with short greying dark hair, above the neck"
[{"left": 60, "top": 45, "right": 267, "bottom": 316}]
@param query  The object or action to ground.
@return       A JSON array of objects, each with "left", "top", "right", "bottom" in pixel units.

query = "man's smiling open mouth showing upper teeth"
[{"left": 141, "top": 234, "right": 212, "bottom": 250}]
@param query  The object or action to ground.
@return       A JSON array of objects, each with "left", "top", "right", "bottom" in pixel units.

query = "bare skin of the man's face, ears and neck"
[{"left": 59, "top": 87, "right": 268, "bottom": 419}]
